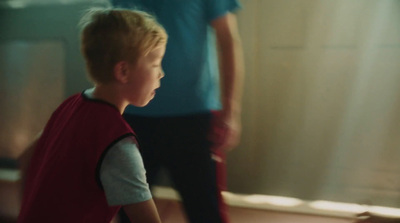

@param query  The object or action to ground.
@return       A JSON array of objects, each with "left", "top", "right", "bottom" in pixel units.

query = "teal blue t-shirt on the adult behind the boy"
[{"left": 112, "top": 0, "right": 240, "bottom": 117}]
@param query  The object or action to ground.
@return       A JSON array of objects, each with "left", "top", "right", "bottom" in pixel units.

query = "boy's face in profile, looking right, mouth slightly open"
[{"left": 128, "top": 44, "right": 165, "bottom": 107}]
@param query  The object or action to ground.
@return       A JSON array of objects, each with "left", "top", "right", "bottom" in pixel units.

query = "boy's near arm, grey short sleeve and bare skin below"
[{"left": 99, "top": 137, "right": 161, "bottom": 223}]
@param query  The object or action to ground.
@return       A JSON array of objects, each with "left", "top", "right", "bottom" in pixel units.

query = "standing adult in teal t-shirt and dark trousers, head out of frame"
[{"left": 111, "top": 0, "right": 243, "bottom": 223}]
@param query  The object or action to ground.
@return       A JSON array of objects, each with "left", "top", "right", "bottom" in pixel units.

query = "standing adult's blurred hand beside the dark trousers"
[{"left": 210, "top": 112, "right": 241, "bottom": 151}]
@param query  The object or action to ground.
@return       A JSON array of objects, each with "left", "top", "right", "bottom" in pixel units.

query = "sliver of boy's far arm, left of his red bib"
[{"left": 17, "top": 131, "right": 42, "bottom": 194}]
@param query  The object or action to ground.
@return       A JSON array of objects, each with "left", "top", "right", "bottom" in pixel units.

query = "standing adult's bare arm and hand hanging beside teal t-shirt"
[{"left": 211, "top": 13, "right": 244, "bottom": 150}]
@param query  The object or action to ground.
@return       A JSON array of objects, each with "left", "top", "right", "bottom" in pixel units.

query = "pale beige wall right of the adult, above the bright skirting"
[{"left": 228, "top": 0, "right": 400, "bottom": 207}]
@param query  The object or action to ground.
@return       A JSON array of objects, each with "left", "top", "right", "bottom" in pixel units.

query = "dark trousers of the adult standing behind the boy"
[{"left": 121, "top": 113, "right": 228, "bottom": 223}]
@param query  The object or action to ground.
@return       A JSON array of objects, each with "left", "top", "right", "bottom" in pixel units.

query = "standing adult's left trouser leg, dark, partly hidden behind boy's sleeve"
[{"left": 119, "top": 114, "right": 161, "bottom": 223}]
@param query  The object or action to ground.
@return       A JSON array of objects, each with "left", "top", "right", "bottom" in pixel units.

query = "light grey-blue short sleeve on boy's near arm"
[{"left": 99, "top": 137, "right": 152, "bottom": 206}]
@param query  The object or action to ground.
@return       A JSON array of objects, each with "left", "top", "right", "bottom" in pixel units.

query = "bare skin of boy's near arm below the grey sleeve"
[{"left": 123, "top": 199, "right": 161, "bottom": 223}]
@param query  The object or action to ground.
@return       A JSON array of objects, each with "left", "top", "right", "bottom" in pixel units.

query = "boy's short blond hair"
[{"left": 79, "top": 8, "right": 168, "bottom": 83}]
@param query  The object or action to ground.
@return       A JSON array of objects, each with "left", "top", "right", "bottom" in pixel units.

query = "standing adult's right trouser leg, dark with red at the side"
[{"left": 163, "top": 114, "right": 228, "bottom": 223}]
